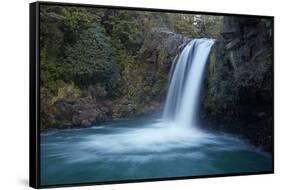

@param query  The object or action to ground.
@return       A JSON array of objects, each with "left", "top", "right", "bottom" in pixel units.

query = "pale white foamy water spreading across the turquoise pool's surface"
[{"left": 42, "top": 120, "right": 256, "bottom": 163}]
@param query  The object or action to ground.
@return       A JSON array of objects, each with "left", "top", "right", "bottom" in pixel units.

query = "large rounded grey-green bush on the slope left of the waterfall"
[{"left": 65, "top": 26, "right": 119, "bottom": 95}]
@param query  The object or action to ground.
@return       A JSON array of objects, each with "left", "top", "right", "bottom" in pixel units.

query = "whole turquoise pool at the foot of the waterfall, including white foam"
[{"left": 41, "top": 118, "right": 272, "bottom": 185}]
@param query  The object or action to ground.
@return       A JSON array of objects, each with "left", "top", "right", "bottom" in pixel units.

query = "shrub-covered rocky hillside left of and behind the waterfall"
[{"left": 40, "top": 5, "right": 220, "bottom": 128}]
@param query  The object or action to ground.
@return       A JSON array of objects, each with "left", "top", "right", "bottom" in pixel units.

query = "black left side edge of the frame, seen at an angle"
[{"left": 29, "top": 2, "right": 40, "bottom": 188}]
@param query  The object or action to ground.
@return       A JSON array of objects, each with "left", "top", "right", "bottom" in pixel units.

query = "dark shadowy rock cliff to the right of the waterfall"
[{"left": 204, "top": 16, "right": 273, "bottom": 150}]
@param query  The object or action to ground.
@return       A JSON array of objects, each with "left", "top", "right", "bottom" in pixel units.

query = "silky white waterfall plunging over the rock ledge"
[{"left": 163, "top": 38, "right": 214, "bottom": 127}]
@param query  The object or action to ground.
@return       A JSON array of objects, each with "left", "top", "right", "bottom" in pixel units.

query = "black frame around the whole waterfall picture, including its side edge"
[{"left": 29, "top": 1, "right": 274, "bottom": 188}]
